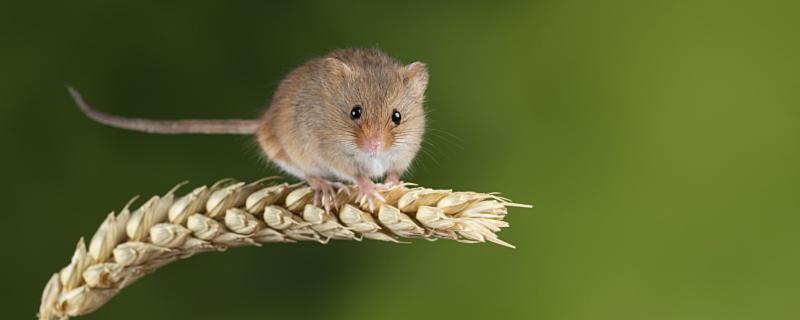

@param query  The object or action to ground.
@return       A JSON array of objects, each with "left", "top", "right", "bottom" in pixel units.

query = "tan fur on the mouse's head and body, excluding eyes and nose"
[{"left": 256, "top": 49, "right": 428, "bottom": 182}]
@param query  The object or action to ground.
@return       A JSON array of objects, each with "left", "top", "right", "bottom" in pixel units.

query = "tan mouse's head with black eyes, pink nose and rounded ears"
[{"left": 322, "top": 49, "right": 428, "bottom": 162}]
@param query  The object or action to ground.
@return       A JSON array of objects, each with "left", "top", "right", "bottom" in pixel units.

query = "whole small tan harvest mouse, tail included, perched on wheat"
[{"left": 68, "top": 48, "right": 428, "bottom": 210}]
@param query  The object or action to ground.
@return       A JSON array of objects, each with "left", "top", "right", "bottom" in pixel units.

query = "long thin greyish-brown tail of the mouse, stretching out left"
[{"left": 67, "top": 86, "right": 258, "bottom": 134}]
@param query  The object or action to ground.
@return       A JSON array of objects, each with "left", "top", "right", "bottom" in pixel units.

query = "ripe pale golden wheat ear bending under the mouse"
[{"left": 39, "top": 178, "right": 530, "bottom": 320}]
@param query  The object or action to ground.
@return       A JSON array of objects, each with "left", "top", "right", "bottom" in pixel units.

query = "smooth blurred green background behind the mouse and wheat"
[{"left": 0, "top": 1, "right": 800, "bottom": 319}]
